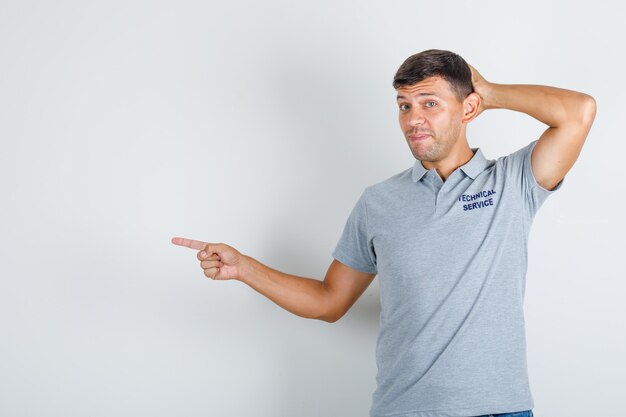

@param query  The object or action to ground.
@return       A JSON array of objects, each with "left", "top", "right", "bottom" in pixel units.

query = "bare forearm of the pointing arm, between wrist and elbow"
[{"left": 240, "top": 256, "right": 328, "bottom": 321}]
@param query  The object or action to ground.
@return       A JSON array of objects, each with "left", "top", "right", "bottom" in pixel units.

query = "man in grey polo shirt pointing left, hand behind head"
[{"left": 173, "top": 50, "right": 596, "bottom": 417}]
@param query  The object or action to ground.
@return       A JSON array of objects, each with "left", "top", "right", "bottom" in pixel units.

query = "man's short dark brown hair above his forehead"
[{"left": 393, "top": 49, "right": 474, "bottom": 100}]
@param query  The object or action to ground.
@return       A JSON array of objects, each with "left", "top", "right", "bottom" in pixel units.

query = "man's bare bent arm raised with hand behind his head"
[{"left": 470, "top": 66, "right": 596, "bottom": 190}]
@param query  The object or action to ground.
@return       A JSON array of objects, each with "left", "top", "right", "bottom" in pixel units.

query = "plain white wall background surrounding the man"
[{"left": 0, "top": 0, "right": 626, "bottom": 417}]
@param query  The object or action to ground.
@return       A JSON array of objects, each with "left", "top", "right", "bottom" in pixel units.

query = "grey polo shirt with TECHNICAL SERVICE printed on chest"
[{"left": 332, "top": 140, "right": 563, "bottom": 417}]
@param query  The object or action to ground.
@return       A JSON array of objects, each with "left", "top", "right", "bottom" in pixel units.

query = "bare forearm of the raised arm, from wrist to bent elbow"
[{"left": 481, "top": 83, "right": 595, "bottom": 127}]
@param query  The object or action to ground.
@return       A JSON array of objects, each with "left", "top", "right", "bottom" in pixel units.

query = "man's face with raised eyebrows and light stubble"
[{"left": 397, "top": 77, "right": 463, "bottom": 162}]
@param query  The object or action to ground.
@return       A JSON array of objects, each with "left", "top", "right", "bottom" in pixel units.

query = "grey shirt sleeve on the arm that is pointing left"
[{"left": 332, "top": 190, "right": 377, "bottom": 274}]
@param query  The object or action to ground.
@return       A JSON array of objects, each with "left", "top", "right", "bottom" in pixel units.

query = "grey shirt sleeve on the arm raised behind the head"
[{"left": 502, "top": 139, "right": 565, "bottom": 217}]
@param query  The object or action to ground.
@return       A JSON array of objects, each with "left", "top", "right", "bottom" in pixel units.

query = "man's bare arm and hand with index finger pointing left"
[{"left": 172, "top": 237, "right": 375, "bottom": 323}]
